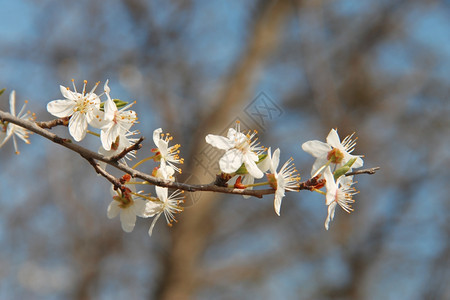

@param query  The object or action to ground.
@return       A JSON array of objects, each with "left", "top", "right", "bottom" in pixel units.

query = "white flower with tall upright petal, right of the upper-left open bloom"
[{"left": 100, "top": 80, "right": 137, "bottom": 150}]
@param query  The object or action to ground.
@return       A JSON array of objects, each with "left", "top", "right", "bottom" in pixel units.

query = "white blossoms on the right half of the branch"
[{"left": 205, "top": 122, "right": 363, "bottom": 230}]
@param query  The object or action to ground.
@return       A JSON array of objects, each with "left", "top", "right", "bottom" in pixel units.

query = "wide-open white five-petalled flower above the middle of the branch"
[{"left": 205, "top": 122, "right": 265, "bottom": 178}]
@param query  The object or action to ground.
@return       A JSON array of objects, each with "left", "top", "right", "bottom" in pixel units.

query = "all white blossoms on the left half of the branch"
[{"left": 4, "top": 80, "right": 183, "bottom": 235}]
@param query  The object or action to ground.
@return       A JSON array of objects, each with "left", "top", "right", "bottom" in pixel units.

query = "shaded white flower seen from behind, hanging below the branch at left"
[{"left": 108, "top": 181, "right": 148, "bottom": 232}]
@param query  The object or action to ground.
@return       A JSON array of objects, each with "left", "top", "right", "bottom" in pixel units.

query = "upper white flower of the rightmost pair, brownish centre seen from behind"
[{"left": 302, "top": 129, "right": 364, "bottom": 177}]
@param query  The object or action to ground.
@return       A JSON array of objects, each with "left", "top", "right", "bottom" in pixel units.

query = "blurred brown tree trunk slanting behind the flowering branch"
[{"left": 156, "top": 1, "right": 293, "bottom": 299}]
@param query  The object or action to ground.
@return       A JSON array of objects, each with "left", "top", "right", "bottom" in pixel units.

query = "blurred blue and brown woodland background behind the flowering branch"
[{"left": 0, "top": 0, "right": 450, "bottom": 299}]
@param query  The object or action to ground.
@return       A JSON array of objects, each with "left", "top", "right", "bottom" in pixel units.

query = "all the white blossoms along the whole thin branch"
[{"left": 0, "top": 80, "right": 370, "bottom": 236}]
